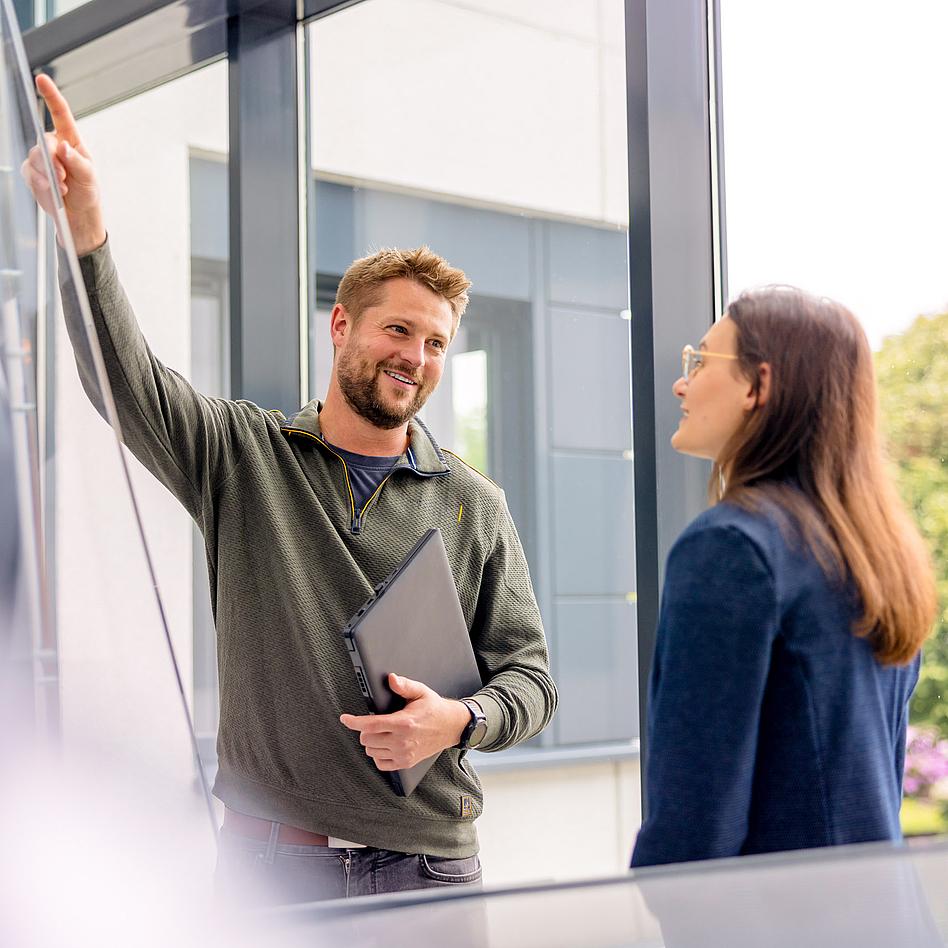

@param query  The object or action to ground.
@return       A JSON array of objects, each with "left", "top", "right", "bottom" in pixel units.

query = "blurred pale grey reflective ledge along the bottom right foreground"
[{"left": 274, "top": 839, "right": 948, "bottom": 948}]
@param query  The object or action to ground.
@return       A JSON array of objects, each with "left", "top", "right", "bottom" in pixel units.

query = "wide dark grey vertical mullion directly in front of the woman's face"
[{"left": 626, "top": 0, "right": 714, "bottom": 815}]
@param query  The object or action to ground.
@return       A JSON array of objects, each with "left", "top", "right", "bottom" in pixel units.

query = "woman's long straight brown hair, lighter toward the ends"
[{"left": 709, "top": 287, "right": 937, "bottom": 665}]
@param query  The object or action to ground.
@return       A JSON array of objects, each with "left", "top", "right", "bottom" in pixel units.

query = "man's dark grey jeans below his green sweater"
[{"left": 215, "top": 829, "right": 481, "bottom": 905}]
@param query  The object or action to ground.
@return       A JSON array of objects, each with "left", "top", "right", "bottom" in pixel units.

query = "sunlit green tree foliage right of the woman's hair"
[{"left": 876, "top": 313, "right": 948, "bottom": 737}]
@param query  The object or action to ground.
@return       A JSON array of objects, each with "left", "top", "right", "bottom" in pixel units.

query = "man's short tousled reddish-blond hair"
[{"left": 336, "top": 247, "right": 471, "bottom": 329}]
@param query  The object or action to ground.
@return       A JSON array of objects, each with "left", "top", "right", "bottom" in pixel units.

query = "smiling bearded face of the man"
[{"left": 333, "top": 277, "right": 454, "bottom": 429}]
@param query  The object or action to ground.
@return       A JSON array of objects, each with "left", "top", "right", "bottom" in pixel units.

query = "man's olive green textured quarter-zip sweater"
[{"left": 64, "top": 239, "right": 556, "bottom": 857}]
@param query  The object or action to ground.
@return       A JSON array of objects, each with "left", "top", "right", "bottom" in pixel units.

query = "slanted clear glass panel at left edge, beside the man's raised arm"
[{"left": 0, "top": 0, "right": 216, "bottom": 945}]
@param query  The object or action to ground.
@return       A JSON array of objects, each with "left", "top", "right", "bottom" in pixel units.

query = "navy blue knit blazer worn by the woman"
[{"left": 632, "top": 504, "right": 918, "bottom": 866}]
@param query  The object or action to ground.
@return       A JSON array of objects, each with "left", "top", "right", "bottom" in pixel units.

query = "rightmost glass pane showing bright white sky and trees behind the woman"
[{"left": 721, "top": 0, "right": 948, "bottom": 832}]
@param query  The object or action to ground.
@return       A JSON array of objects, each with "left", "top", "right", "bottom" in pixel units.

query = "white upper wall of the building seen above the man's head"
[{"left": 310, "top": 0, "right": 628, "bottom": 224}]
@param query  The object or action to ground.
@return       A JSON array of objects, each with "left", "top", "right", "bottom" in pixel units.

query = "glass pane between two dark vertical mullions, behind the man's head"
[{"left": 308, "top": 0, "right": 638, "bottom": 881}]
